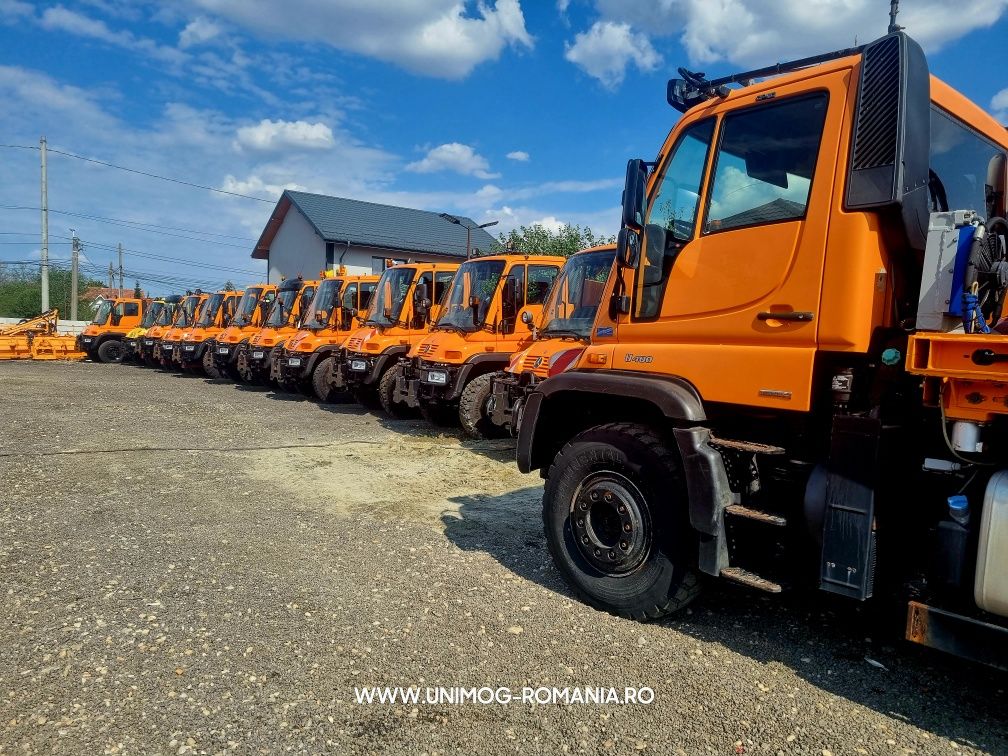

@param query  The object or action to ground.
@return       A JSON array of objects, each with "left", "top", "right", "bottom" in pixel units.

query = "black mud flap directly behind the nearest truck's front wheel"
[{"left": 673, "top": 427, "right": 735, "bottom": 576}]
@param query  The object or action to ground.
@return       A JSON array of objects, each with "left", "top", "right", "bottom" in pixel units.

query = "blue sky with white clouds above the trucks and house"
[{"left": 0, "top": 0, "right": 1008, "bottom": 292}]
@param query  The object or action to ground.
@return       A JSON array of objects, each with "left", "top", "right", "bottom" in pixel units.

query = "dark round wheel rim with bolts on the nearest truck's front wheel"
[{"left": 571, "top": 471, "right": 651, "bottom": 575}]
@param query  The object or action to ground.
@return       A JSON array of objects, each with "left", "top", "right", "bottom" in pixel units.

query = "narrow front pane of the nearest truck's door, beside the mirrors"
[{"left": 634, "top": 118, "right": 715, "bottom": 319}]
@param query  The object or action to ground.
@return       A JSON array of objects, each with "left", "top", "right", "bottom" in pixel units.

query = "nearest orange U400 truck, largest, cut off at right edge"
[{"left": 517, "top": 27, "right": 1008, "bottom": 667}]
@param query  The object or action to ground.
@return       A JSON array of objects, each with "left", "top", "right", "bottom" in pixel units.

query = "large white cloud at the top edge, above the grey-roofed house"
[{"left": 194, "top": 0, "right": 533, "bottom": 79}]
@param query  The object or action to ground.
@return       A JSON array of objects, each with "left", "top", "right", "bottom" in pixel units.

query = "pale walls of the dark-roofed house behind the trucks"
[{"left": 269, "top": 207, "right": 462, "bottom": 283}]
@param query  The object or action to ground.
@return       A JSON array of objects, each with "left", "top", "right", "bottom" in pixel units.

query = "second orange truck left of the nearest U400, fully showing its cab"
[{"left": 394, "top": 255, "right": 564, "bottom": 436}]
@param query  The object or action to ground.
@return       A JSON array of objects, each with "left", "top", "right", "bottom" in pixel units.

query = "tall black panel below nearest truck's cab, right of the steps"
[{"left": 820, "top": 416, "right": 882, "bottom": 601}]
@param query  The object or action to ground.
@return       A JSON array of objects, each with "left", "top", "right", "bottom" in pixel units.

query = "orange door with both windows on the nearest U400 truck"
[{"left": 613, "top": 73, "right": 848, "bottom": 410}]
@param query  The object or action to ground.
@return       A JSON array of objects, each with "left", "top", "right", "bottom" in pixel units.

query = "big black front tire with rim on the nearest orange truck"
[{"left": 542, "top": 423, "right": 700, "bottom": 620}]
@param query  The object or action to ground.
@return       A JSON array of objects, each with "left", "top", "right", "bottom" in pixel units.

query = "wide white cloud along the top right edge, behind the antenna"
[{"left": 596, "top": 0, "right": 1008, "bottom": 66}]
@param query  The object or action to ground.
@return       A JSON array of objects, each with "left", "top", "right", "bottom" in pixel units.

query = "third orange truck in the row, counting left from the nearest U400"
[{"left": 342, "top": 262, "right": 459, "bottom": 416}]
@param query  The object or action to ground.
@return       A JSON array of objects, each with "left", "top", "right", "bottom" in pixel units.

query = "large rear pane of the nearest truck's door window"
[{"left": 704, "top": 93, "right": 829, "bottom": 234}]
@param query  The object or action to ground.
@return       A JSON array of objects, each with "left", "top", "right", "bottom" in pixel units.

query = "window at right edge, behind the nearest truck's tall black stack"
[{"left": 930, "top": 106, "right": 1004, "bottom": 217}]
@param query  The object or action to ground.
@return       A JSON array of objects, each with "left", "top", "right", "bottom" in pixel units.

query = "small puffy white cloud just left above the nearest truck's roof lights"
[{"left": 563, "top": 21, "right": 661, "bottom": 90}]
